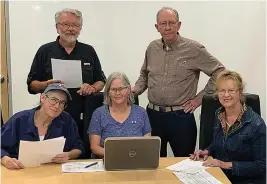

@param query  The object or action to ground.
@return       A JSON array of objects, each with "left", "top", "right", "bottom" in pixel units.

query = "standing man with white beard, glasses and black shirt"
[{"left": 27, "top": 9, "right": 106, "bottom": 145}]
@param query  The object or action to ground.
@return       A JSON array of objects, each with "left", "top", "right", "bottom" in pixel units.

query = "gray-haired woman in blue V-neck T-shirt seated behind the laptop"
[{"left": 88, "top": 72, "right": 151, "bottom": 158}]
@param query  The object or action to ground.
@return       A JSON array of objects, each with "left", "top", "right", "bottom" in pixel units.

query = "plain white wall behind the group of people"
[{"left": 9, "top": 1, "right": 266, "bottom": 120}]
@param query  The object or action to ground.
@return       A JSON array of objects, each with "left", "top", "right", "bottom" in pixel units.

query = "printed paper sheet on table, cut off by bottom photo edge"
[{"left": 173, "top": 170, "right": 222, "bottom": 184}]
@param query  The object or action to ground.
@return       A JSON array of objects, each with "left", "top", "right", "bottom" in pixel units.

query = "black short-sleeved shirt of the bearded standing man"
[{"left": 27, "top": 37, "right": 106, "bottom": 94}]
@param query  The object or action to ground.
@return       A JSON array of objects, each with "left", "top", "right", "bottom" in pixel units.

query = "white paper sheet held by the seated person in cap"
[{"left": 19, "top": 137, "right": 66, "bottom": 167}]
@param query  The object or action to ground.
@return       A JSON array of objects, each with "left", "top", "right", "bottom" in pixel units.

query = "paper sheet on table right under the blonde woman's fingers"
[{"left": 167, "top": 158, "right": 209, "bottom": 174}]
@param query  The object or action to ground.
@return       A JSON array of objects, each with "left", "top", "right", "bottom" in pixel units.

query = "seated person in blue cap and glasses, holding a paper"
[{"left": 1, "top": 83, "right": 84, "bottom": 169}]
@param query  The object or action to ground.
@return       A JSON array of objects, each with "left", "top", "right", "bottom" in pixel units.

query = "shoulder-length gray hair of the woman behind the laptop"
[{"left": 104, "top": 72, "right": 134, "bottom": 105}]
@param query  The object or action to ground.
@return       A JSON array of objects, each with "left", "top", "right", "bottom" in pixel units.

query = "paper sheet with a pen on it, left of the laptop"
[{"left": 62, "top": 161, "right": 105, "bottom": 173}]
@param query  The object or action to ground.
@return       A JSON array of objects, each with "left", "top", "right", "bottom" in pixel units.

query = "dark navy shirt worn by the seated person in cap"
[{"left": 1, "top": 107, "right": 84, "bottom": 158}]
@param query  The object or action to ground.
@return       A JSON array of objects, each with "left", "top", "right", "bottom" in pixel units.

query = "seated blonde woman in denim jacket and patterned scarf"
[{"left": 190, "top": 71, "right": 266, "bottom": 183}]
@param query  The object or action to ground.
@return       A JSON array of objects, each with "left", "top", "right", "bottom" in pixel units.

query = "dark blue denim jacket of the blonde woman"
[{"left": 207, "top": 106, "right": 266, "bottom": 178}]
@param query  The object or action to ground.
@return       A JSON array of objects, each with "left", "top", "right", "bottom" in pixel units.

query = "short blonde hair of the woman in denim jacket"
[{"left": 215, "top": 70, "right": 245, "bottom": 102}]
